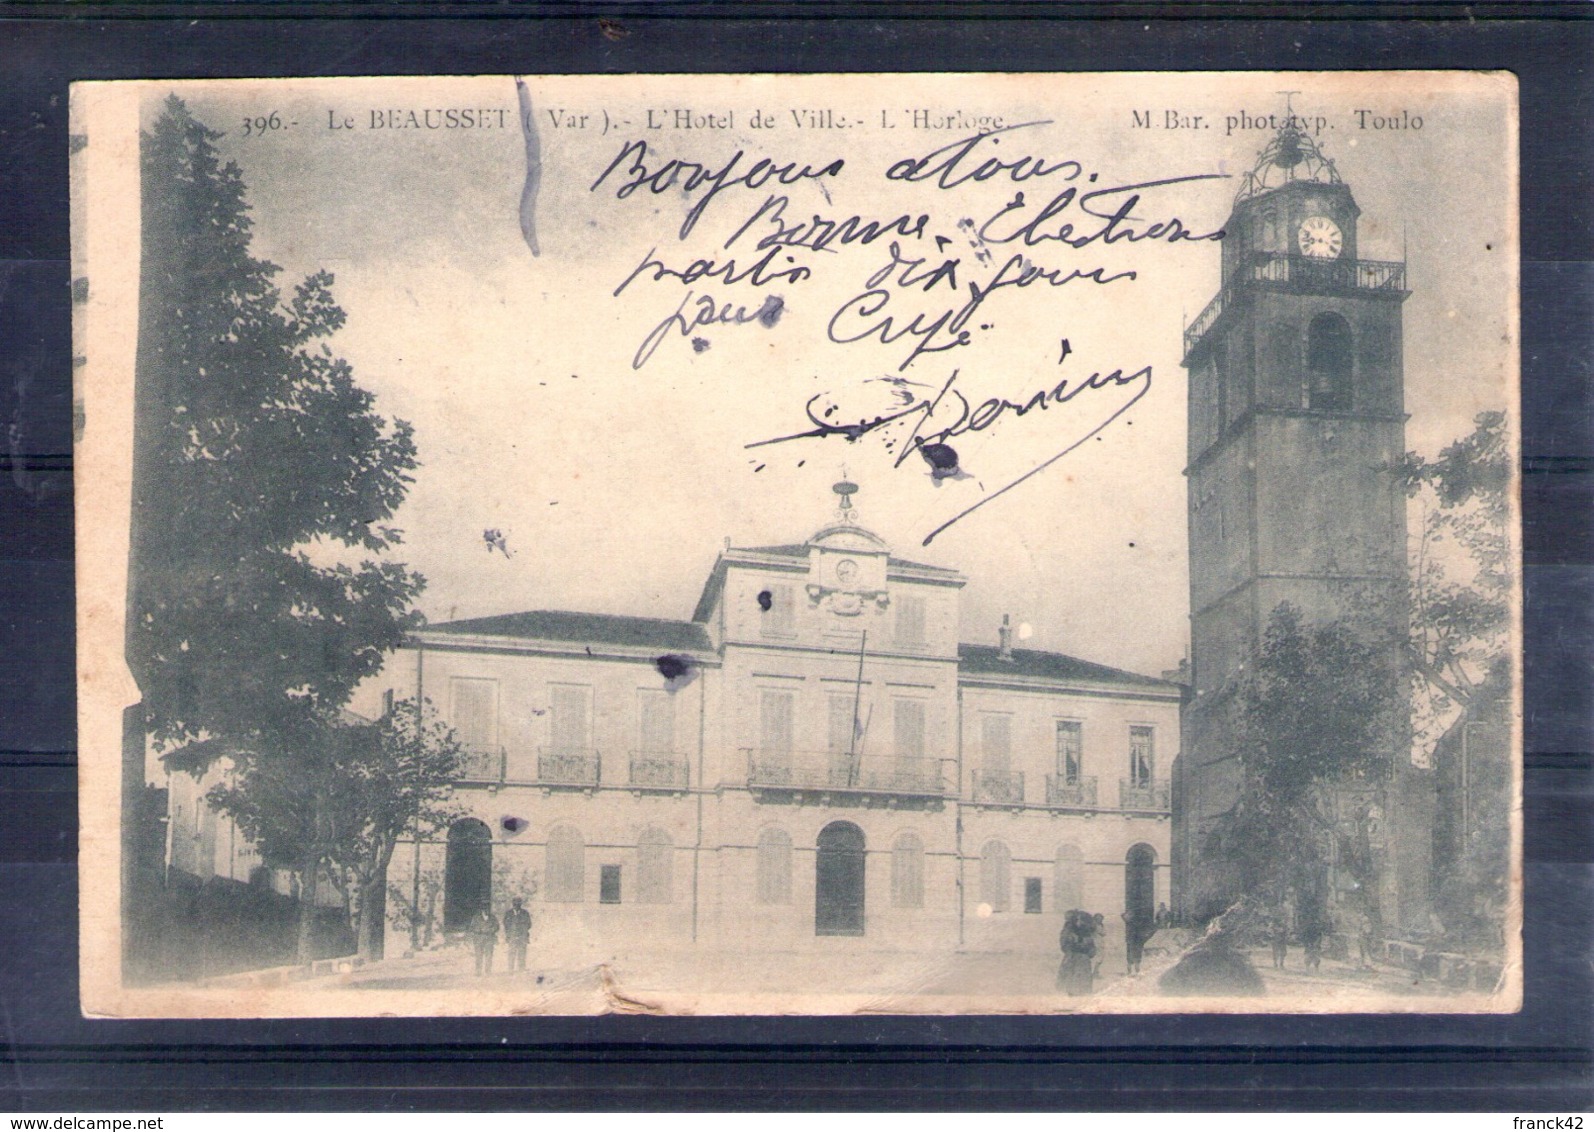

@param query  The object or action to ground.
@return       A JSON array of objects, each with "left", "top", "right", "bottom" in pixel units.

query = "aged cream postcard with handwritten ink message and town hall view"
[{"left": 72, "top": 72, "right": 1521, "bottom": 1017}]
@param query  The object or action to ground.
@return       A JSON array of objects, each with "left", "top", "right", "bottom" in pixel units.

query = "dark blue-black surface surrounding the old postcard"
[{"left": 0, "top": 3, "right": 1594, "bottom": 1113}]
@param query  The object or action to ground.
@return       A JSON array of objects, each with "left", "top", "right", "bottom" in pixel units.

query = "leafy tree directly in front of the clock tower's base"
[{"left": 1211, "top": 603, "right": 1400, "bottom": 915}]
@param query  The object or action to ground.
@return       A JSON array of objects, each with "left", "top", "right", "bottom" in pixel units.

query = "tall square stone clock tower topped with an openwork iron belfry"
[{"left": 1173, "top": 118, "right": 1425, "bottom": 923}]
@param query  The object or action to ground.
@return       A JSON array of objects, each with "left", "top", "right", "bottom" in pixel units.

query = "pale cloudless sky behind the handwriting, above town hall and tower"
[{"left": 155, "top": 73, "right": 1516, "bottom": 674}]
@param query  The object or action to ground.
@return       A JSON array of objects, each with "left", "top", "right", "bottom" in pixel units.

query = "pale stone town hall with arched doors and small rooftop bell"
[{"left": 336, "top": 483, "right": 1183, "bottom": 953}]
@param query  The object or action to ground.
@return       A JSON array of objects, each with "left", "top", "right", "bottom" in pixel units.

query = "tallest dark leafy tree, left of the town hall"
[{"left": 137, "top": 96, "right": 424, "bottom": 969}]
